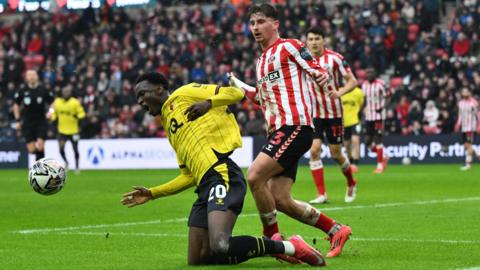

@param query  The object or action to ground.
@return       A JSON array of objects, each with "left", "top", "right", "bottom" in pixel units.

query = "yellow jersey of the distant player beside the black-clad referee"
[{"left": 52, "top": 97, "right": 85, "bottom": 135}]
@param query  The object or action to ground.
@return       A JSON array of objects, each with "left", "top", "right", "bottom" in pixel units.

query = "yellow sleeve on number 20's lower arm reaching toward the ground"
[{"left": 149, "top": 168, "right": 195, "bottom": 199}]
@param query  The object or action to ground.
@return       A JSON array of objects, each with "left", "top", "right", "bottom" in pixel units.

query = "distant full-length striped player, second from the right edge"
[{"left": 362, "top": 68, "right": 390, "bottom": 173}]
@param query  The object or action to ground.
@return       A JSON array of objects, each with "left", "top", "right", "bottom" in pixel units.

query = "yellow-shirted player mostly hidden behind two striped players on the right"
[{"left": 341, "top": 86, "right": 365, "bottom": 173}]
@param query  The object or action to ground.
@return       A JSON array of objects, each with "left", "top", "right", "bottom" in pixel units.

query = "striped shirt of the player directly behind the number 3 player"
[{"left": 309, "top": 49, "right": 350, "bottom": 119}]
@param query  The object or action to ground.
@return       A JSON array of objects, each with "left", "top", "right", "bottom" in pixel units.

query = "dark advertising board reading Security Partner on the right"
[{"left": 254, "top": 134, "right": 480, "bottom": 165}]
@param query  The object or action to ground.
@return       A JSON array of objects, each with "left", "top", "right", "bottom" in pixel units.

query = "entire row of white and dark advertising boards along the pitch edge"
[{"left": 21, "top": 134, "right": 480, "bottom": 169}]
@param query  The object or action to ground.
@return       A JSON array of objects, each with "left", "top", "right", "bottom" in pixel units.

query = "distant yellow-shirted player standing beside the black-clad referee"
[{"left": 47, "top": 86, "right": 85, "bottom": 173}]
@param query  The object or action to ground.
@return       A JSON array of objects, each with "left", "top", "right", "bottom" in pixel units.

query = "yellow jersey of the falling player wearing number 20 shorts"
[{"left": 150, "top": 83, "right": 244, "bottom": 198}]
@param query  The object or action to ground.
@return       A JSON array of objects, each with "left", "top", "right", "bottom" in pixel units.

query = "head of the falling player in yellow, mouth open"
[{"left": 135, "top": 81, "right": 168, "bottom": 116}]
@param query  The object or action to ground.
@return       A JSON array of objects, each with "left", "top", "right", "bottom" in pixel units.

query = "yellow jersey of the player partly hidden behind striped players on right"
[{"left": 342, "top": 86, "right": 365, "bottom": 127}]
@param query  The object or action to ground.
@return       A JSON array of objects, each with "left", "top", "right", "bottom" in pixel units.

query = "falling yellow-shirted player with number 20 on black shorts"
[{"left": 122, "top": 73, "right": 325, "bottom": 265}]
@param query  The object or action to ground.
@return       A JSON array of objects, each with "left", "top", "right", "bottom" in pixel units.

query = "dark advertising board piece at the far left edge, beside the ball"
[{"left": 0, "top": 142, "right": 28, "bottom": 169}]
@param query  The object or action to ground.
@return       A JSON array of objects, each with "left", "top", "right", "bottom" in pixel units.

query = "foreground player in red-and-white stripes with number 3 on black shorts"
[{"left": 232, "top": 4, "right": 351, "bottom": 263}]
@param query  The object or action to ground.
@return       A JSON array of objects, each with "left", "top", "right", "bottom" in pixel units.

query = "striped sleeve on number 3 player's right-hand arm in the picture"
[{"left": 285, "top": 39, "right": 327, "bottom": 78}]
